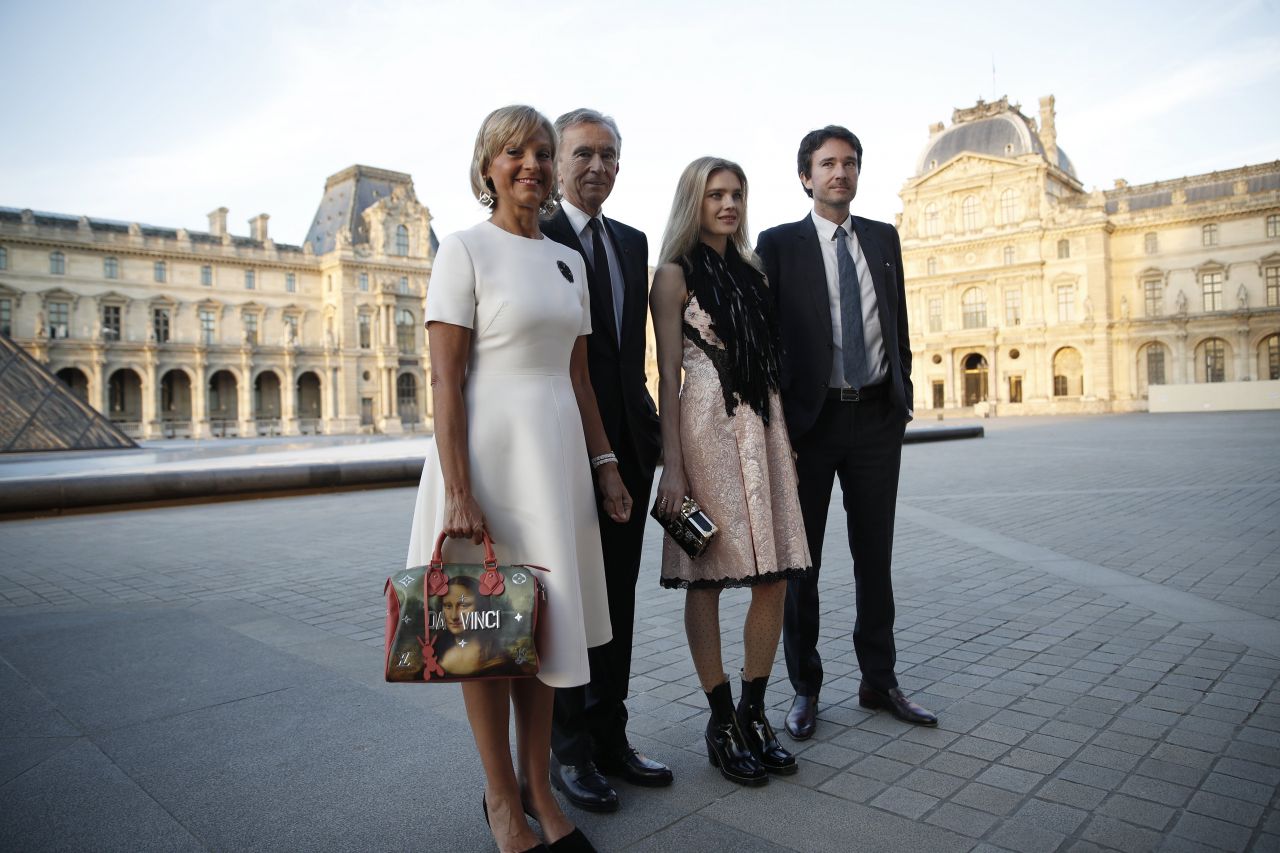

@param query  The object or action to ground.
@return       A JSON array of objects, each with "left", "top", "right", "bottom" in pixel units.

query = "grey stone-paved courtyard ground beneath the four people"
[{"left": 0, "top": 412, "right": 1280, "bottom": 853}]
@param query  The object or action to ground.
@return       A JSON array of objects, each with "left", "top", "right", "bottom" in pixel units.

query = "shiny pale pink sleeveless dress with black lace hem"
[{"left": 662, "top": 296, "right": 812, "bottom": 588}]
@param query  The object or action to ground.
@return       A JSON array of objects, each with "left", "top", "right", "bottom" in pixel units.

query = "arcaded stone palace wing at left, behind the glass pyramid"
[{"left": 0, "top": 165, "right": 436, "bottom": 438}]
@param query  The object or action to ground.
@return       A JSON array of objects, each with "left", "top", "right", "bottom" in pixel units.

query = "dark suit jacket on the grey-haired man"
[{"left": 541, "top": 209, "right": 662, "bottom": 471}]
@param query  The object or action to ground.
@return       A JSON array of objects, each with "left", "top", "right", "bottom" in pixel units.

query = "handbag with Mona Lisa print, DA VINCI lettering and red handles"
[{"left": 383, "top": 530, "right": 547, "bottom": 683}]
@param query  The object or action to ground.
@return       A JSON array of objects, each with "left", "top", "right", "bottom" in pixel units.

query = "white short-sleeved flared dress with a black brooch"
[{"left": 406, "top": 222, "right": 613, "bottom": 686}]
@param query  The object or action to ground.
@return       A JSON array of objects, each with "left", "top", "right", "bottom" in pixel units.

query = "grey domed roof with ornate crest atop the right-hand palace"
[{"left": 915, "top": 97, "right": 1079, "bottom": 181}]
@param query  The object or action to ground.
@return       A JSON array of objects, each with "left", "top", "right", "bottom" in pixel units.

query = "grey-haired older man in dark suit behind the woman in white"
[{"left": 543, "top": 109, "right": 672, "bottom": 812}]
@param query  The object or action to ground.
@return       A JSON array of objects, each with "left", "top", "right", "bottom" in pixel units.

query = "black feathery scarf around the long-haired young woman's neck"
[{"left": 680, "top": 242, "right": 778, "bottom": 424}]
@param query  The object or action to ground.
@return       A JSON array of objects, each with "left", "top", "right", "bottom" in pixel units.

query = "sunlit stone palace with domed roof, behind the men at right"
[{"left": 897, "top": 96, "right": 1280, "bottom": 415}]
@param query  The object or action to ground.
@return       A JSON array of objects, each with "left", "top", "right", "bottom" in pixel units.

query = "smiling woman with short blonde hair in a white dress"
[{"left": 407, "top": 106, "right": 631, "bottom": 853}]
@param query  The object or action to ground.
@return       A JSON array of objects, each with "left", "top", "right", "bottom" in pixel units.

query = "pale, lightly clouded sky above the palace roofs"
[{"left": 0, "top": 0, "right": 1280, "bottom": 258}]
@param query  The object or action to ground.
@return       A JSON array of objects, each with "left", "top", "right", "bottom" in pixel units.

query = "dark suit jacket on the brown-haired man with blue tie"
[{"left": 755, "top": 216, "right": 913, "bottom": 439}]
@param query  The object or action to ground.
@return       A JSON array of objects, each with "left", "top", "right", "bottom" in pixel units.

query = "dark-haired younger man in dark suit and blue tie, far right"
[{"left": 756, "top": 126, "right": 937, "bottom": 740}]
